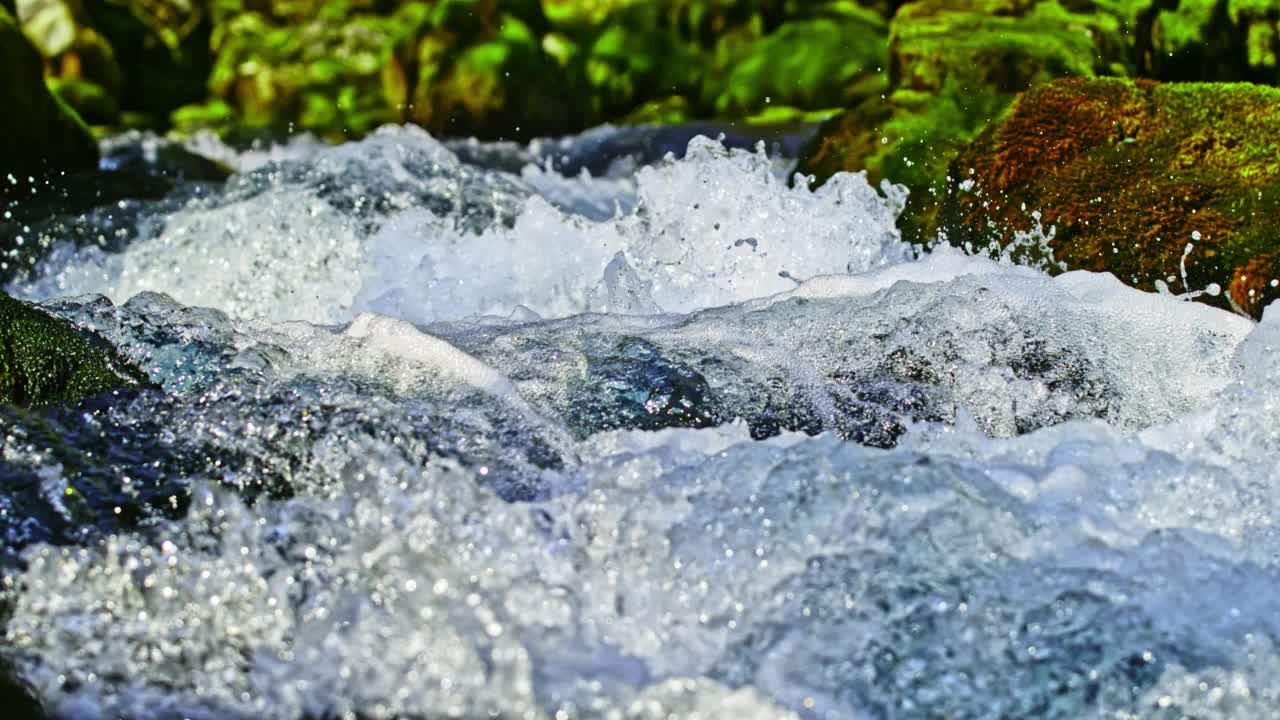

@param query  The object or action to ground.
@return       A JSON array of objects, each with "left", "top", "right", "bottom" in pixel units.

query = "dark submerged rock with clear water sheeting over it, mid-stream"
[{"left": 433, "top": 274, "right": 1131, "bottom": 447}]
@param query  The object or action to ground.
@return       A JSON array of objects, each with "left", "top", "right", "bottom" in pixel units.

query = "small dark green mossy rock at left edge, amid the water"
[{"left": 0, "top": 292, "right": 147, "bottom": 406}]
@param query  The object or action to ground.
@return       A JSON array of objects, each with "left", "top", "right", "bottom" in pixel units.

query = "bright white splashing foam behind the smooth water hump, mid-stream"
[{"left": 357, "top": 133, "right": 908, "bottom": 323}]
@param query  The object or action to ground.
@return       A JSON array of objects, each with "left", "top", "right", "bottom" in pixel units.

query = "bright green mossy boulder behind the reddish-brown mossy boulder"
[{"left": 796, "top": 0, "right": 1129, "bottom": 241}]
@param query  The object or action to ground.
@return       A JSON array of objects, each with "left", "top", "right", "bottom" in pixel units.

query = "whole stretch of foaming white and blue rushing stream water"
[{"left": 0, "top": 129, "right": 1280, "bottom": 720}]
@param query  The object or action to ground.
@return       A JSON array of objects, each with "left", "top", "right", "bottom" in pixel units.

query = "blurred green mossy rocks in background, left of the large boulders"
[{"left": 0, "top": 0, "right": 893, "bottom": 140}]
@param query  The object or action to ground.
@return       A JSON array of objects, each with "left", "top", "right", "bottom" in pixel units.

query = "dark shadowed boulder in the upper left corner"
[{"left": 0, "top": 8, "right": 97, "bottom": 179}]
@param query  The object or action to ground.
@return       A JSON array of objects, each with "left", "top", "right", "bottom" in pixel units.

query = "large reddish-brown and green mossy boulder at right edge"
[{"left": 938, "top": 78, "right": 1280, "bottom": 316}]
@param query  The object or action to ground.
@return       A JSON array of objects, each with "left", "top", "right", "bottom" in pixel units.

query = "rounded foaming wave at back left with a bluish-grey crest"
[{"left": 12, "top": 127, "right": 530, "bottom": 323}]
